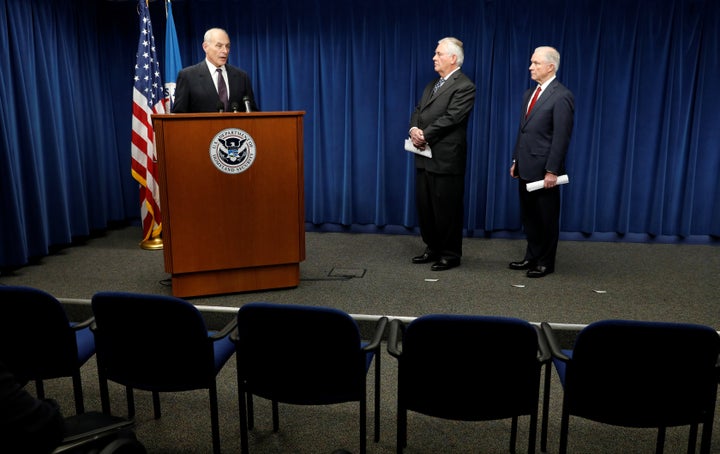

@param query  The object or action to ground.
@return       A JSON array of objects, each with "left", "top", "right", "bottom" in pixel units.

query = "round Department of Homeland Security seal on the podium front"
[{"left": 210, "top": 128, "right": 255, "bottom": 174}]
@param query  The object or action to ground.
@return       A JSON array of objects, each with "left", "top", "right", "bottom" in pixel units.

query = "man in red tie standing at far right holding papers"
[{"left": 510, "top": 46, "right": 575, "bottom": 277}]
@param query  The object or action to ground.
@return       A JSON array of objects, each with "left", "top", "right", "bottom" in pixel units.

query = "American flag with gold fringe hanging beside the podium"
[{"left": 131, "top": 0, "right": 165, "bottom": 241}]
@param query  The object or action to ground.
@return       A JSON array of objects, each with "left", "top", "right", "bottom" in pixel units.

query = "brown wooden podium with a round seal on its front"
[{"left": 153, "top": 112, "right": 305, "bottom": 297}]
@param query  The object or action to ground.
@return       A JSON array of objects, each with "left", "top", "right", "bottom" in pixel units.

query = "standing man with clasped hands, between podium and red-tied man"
[{"left": 410, "top": 38, "right": 475, "bottom": 271}]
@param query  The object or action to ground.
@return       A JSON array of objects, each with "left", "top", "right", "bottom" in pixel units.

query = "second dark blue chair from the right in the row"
[{"left": 388, "top": 314, "right": 550, "bottom": 453}]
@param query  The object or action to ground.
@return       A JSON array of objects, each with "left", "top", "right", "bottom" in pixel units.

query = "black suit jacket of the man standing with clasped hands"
[{"left": 410, "top": 70, "right": 475, "bottom": 175}]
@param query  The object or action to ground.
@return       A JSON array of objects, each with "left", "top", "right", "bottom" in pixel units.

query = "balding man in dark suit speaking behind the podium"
[{"left": 173, "top": 28, "right": 258, "bottom": 113}]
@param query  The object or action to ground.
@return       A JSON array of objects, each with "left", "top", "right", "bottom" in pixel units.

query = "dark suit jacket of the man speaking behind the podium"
[{"left": 172, "top": 60, "right": 258, "bottom": 113}]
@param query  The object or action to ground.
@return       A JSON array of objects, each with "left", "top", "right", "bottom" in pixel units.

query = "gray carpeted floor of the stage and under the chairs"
[{"left": 0, "top": 227, "right": 720, "bottom": 454}]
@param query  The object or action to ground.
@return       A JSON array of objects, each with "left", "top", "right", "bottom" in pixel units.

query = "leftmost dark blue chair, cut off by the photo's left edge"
[{"left": 0, "top": 286, "right": 95, "bottom": 414}]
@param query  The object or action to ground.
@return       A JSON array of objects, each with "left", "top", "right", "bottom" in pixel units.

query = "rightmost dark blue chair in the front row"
[{"left": 541, "top": 320, "right": 720, "bottom": 454}]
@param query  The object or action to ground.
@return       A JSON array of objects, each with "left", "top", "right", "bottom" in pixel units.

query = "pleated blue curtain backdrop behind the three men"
[{"left": 0, "top": 0, "right": 720, "bottom": 268}]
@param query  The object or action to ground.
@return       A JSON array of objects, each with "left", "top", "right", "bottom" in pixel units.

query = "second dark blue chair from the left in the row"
[{"left": 92, "top": 292, "right": 236, "bottom": 453}]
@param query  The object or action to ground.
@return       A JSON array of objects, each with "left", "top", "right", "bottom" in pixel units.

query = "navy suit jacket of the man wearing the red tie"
[{"left": 513, "top": 79, "right": 575, "bottom": 181}]
